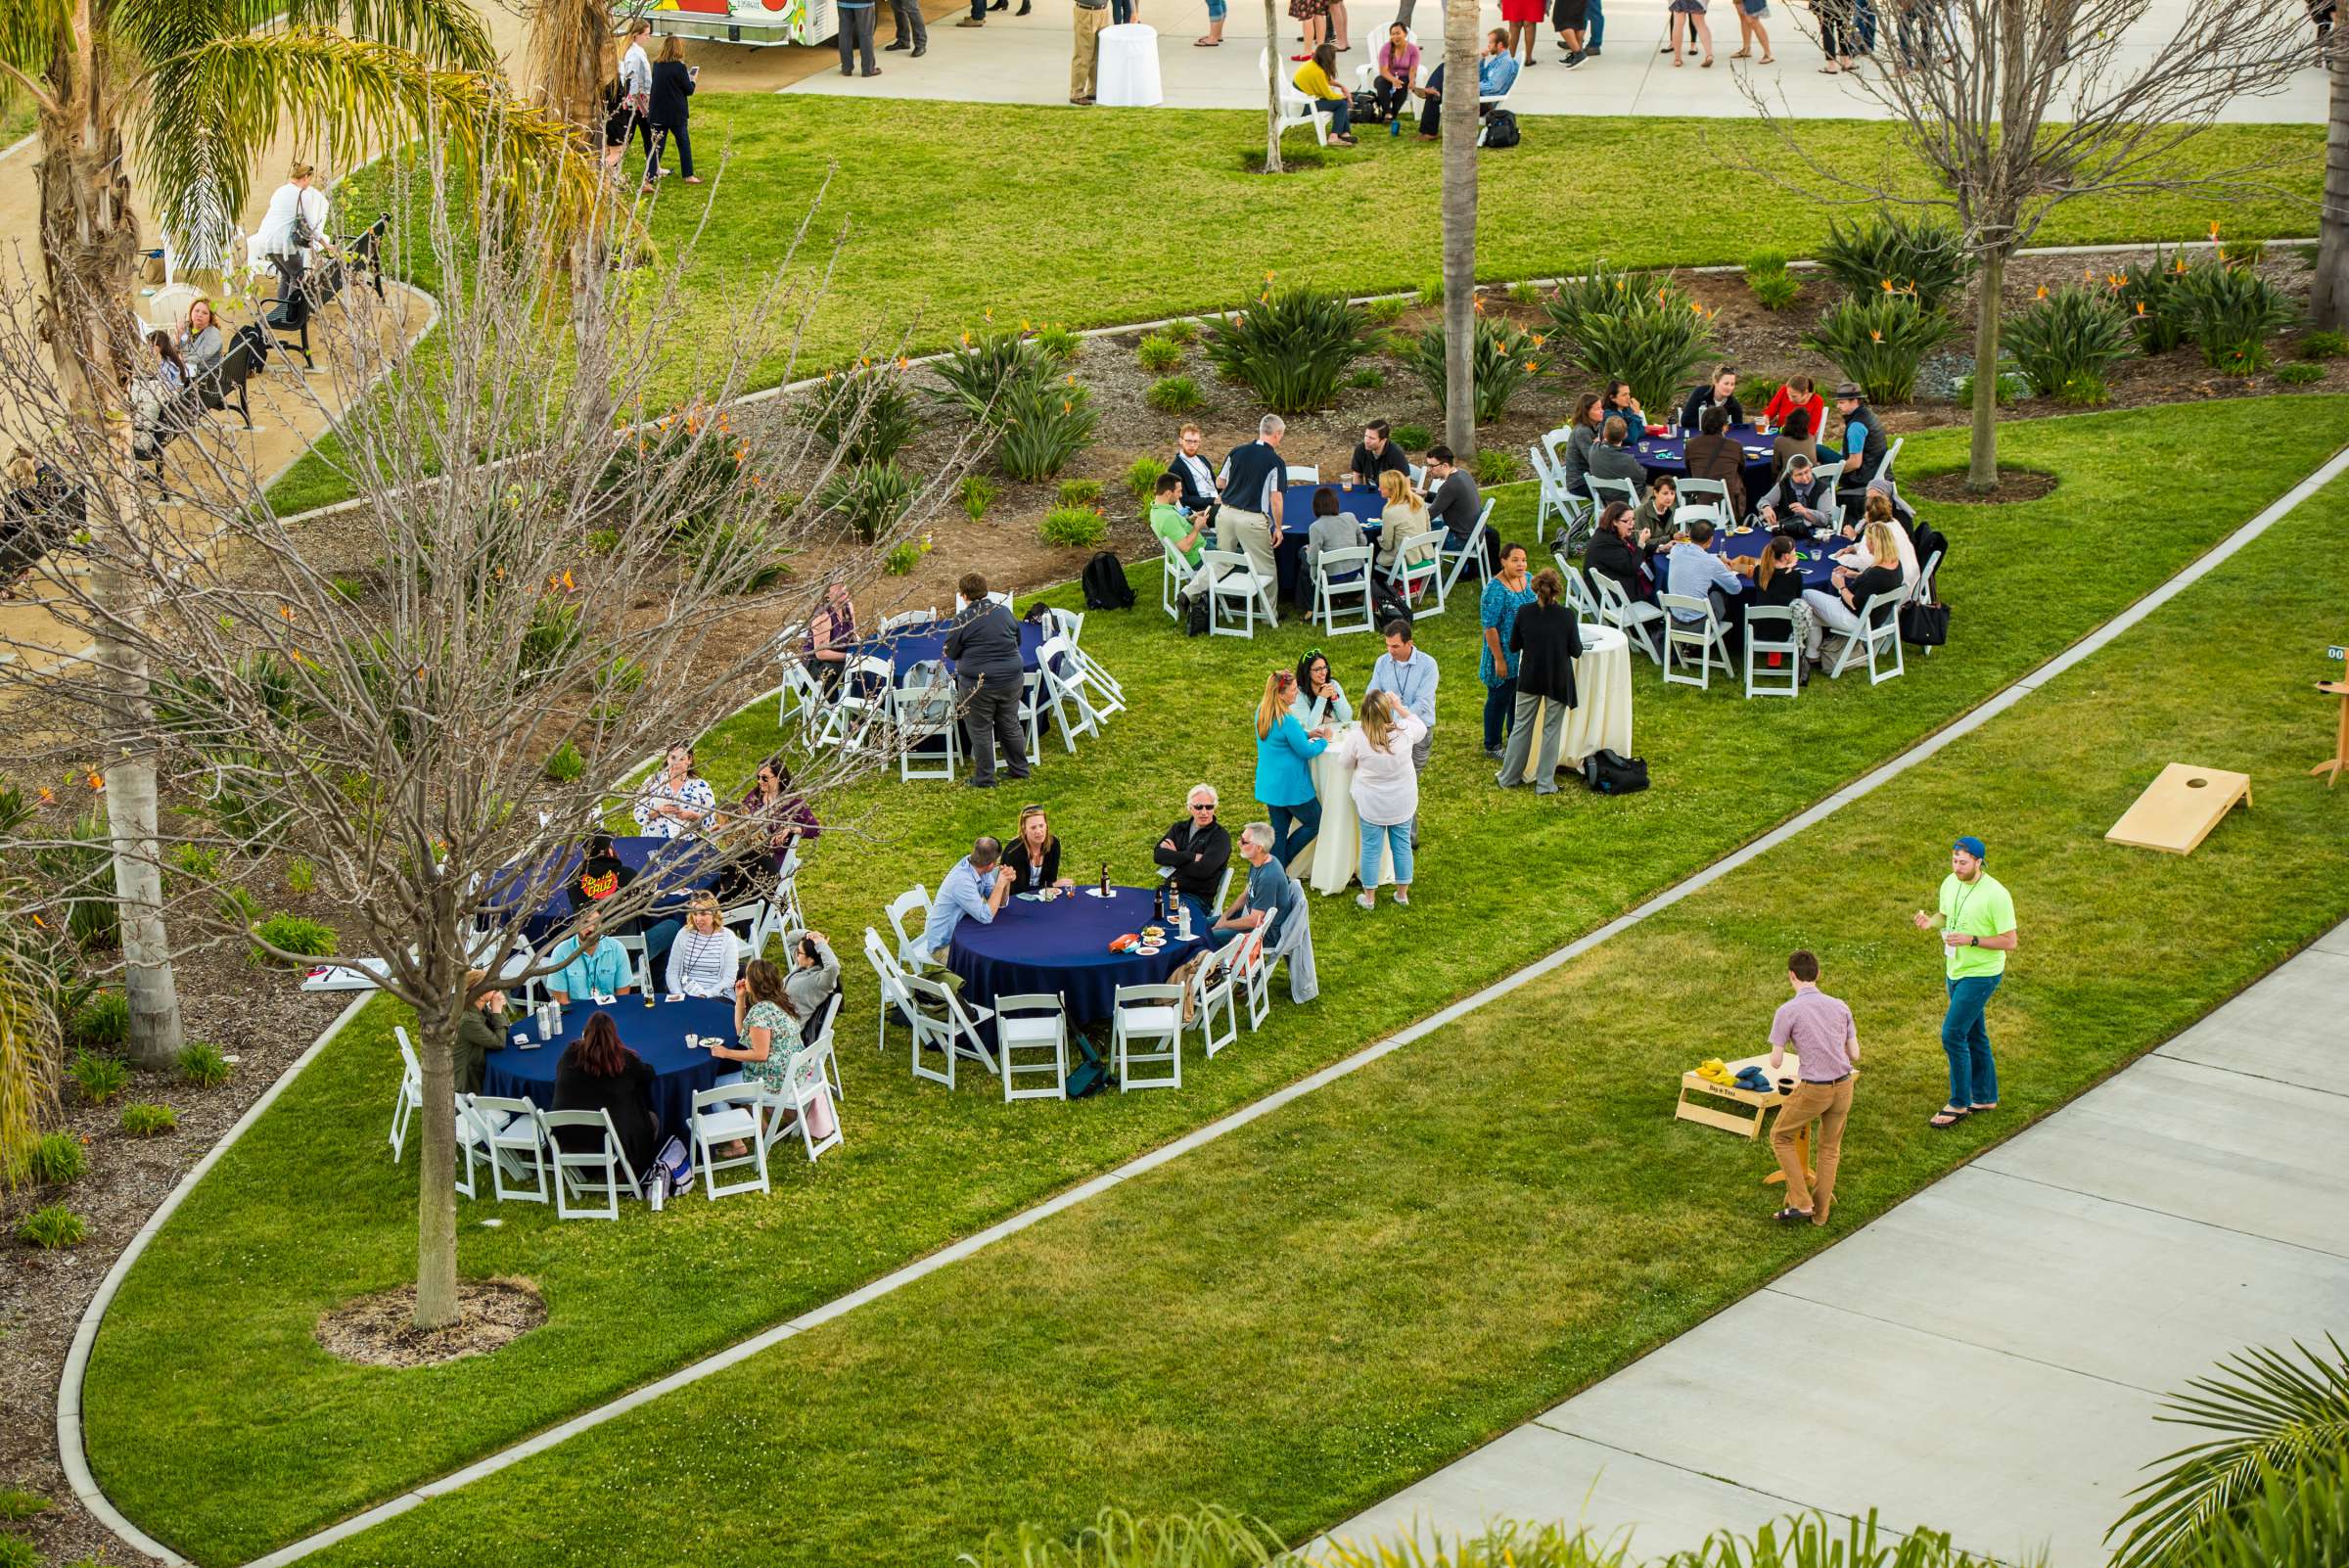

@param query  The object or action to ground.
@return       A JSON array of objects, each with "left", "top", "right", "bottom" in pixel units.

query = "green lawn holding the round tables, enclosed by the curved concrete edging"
[{"left": 84, "top": 396, "right": 2349, "bottom": 1563}]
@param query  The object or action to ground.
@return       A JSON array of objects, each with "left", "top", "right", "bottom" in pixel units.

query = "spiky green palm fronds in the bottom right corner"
[{"left": 2104, "top": 1333, "right": 2349, "bottom": 1568}]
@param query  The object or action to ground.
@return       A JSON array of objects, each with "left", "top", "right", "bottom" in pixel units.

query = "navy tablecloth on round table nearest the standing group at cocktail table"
[{"left": 946, "top": 888, "right": 1210, "bottom": 1033}]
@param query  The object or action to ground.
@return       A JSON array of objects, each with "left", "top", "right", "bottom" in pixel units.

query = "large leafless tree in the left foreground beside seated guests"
[{"left": 0, "top": 160, "right": 951, "bottom": 1326}]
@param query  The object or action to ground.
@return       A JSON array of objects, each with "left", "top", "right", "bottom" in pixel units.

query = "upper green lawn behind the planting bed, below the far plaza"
[{"left": 272, "top": 94, "right": 2324, "bottom": 512}]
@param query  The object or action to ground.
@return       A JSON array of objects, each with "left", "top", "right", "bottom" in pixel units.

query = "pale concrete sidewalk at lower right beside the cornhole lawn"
[{"left": 1332, "top": 925, "right": 2349, "bottom": 1566}]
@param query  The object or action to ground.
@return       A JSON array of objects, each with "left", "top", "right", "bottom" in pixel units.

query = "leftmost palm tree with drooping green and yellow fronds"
[{"left": 0, "top": 0, "right": 592, "bottom": 1066}]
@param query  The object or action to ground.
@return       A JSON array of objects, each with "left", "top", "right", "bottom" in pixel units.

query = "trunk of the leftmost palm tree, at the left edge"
[{"left": 35, "top": 67, "right": 181, "bottom": 1068}]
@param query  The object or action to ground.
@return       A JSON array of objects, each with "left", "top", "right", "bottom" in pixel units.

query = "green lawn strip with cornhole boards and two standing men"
[{"left": 279, "top": 437, "right": 2349, "bottom": 1568}]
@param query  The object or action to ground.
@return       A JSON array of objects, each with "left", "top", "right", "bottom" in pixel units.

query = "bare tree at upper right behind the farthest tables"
[{"left": 1738, "top": 0, "right": 2314, "bottom": 493}]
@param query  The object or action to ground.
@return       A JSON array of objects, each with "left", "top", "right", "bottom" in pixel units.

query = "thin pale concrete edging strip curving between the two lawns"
[{"left": 59, "top": 434, "right": 2349, "bottom": 1568}]
